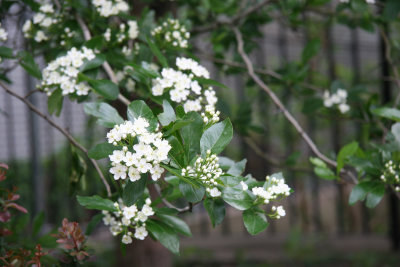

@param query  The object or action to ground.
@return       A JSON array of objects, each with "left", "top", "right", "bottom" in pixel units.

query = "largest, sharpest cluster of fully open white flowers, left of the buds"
[{"left": 107, "top": 117, "right": 171, "bottom": 182}]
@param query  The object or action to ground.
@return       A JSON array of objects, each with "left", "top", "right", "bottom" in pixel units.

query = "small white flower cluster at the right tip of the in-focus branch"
[{"left": 251, "top": 176, "right": 290, "bottom": 204}]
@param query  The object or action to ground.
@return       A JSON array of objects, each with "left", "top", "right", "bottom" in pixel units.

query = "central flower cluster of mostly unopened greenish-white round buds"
[{"left": 182, "top": 150, "right": 223, "bottom": 197}]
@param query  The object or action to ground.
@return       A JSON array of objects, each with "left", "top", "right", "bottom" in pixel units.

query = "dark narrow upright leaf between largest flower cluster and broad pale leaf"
[{"left": 181, "top": 112, "right": 203, "bottom": 162}]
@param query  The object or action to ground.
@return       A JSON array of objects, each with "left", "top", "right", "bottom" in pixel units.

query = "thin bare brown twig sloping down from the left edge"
[{"left": 0, "top": 82, "right": 111, "bottom": 197}]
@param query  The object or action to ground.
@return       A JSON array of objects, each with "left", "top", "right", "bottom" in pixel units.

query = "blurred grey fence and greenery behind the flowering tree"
[{"left": 0, "top": 1, "right": 400, "bottom": 266}]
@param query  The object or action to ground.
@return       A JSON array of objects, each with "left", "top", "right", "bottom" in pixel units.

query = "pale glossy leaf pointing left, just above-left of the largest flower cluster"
[{"left": 84, "top": 103, "right": 124, "bottom": 128}]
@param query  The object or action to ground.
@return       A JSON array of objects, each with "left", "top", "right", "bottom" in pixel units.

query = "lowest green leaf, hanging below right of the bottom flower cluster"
[{"left": 146, "top": 219, "right": 179, "bottom": 254}]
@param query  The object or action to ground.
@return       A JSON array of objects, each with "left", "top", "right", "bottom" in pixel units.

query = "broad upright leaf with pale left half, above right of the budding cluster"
[{"left": 200, "top": 119, "right": 233, "bottom": 155}]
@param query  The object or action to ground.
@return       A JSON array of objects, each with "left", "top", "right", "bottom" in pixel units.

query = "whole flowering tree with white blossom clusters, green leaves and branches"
[{"left": 0, "top": 0, "right": 400, "bottom": 257}]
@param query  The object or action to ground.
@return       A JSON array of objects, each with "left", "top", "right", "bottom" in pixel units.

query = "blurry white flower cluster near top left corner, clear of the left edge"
[{"left": 22, "top": 3, "right": 59, "bottom": 43}]
